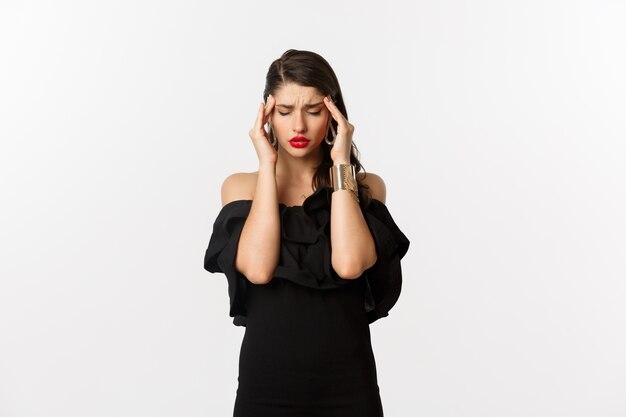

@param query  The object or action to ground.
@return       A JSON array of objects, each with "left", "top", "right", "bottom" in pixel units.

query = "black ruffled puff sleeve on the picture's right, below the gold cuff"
[{"left": 363, "top": 199, "right": 409, "bottom": 323}]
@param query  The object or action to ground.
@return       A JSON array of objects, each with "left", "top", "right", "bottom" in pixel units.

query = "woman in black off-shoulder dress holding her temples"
[{"left": 204, "top": 50, "right": 409, "bottom": 417}]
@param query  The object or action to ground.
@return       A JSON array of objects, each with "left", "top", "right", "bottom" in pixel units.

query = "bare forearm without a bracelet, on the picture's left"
[{"left": 235, "top": 163, "right": 280, "bottom": 284}]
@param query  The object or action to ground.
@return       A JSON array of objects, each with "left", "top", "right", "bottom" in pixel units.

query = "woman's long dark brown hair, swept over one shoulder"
[{"left": 263, "top": 49, "right": 370, "bottom": 207}]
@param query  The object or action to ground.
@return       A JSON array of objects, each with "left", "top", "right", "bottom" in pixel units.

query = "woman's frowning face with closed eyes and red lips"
[{"left": 271, "top": 83, "right": 331, "bottom": 156}]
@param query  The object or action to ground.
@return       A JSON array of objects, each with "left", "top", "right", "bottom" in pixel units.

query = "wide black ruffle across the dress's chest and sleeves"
[{"left": 204, "top": 188, "right": 409, "bottom": 326}]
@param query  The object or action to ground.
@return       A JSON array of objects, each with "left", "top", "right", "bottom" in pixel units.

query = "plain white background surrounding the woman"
[{"left": 0, "top": 0, "right": 626, "bottom": 417}]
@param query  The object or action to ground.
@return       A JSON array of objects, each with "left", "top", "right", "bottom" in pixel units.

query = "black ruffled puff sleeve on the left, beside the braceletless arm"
[{"left": 204, "top": 200, "right": 252, "bottom": 326}]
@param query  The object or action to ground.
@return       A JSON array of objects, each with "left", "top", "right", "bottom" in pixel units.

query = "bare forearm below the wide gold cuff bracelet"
[{"left": 330, "top": 190, "right": 377, "bottom": 279}]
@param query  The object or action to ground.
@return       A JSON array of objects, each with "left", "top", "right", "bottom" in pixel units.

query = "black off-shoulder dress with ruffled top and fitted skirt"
[{"left": 204, "top": 188, "right": 409, "bottom": 417}]
